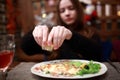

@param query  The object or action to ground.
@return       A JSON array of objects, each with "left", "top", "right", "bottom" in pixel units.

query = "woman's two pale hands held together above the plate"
[{"left": 33, "top": 25, "right": 71, "bottom": 50}]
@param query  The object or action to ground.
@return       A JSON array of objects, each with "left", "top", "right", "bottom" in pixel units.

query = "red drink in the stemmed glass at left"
[{"left": 0, "top": 50, "right": 14, "bottom": 68}]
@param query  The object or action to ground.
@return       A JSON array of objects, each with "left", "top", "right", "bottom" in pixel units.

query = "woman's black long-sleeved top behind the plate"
[{"left": 21, "top": 31, "right": 102, "bottom": 61}]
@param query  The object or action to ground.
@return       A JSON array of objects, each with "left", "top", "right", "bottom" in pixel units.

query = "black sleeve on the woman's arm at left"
[{"left": 20, "top": 31, "right": 43, "bottom": 55}]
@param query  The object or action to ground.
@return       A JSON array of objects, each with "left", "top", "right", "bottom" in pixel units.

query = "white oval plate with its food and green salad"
[{"left": 31, "top": 59, "right": 107, "bottom": 79}]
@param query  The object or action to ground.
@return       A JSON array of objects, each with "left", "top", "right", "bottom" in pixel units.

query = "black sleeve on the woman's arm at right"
[{"left": 68, "top": 32, "right": 102, "bottom": 60}]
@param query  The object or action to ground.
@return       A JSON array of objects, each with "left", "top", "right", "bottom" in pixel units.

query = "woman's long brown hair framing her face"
[{"left": 57, "top": 0, "right": 84, "bottom": 31}]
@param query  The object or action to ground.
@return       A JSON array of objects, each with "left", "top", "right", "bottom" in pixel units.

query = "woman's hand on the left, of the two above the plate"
[{"left": 32, "top": 25, "right": 49, "bottom": 47}]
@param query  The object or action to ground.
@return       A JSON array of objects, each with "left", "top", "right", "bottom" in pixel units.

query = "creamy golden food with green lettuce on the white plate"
[{"left": 35, "top": 60, "right": 101, "bottom": 76}]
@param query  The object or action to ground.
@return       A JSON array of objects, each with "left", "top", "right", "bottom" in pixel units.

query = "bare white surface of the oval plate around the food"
[{"left": 31, "top": 60, "right": 107, "bottom": 79}]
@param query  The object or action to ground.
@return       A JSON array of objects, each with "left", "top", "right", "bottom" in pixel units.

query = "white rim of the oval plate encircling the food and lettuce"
[{"left": 30, "top": 59, "right": 108, "bottom": 79}]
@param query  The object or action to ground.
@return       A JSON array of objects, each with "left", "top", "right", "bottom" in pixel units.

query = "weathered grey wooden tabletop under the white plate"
[{"left": 6, "top": 62, "right": 120, "bottom": 80}]
